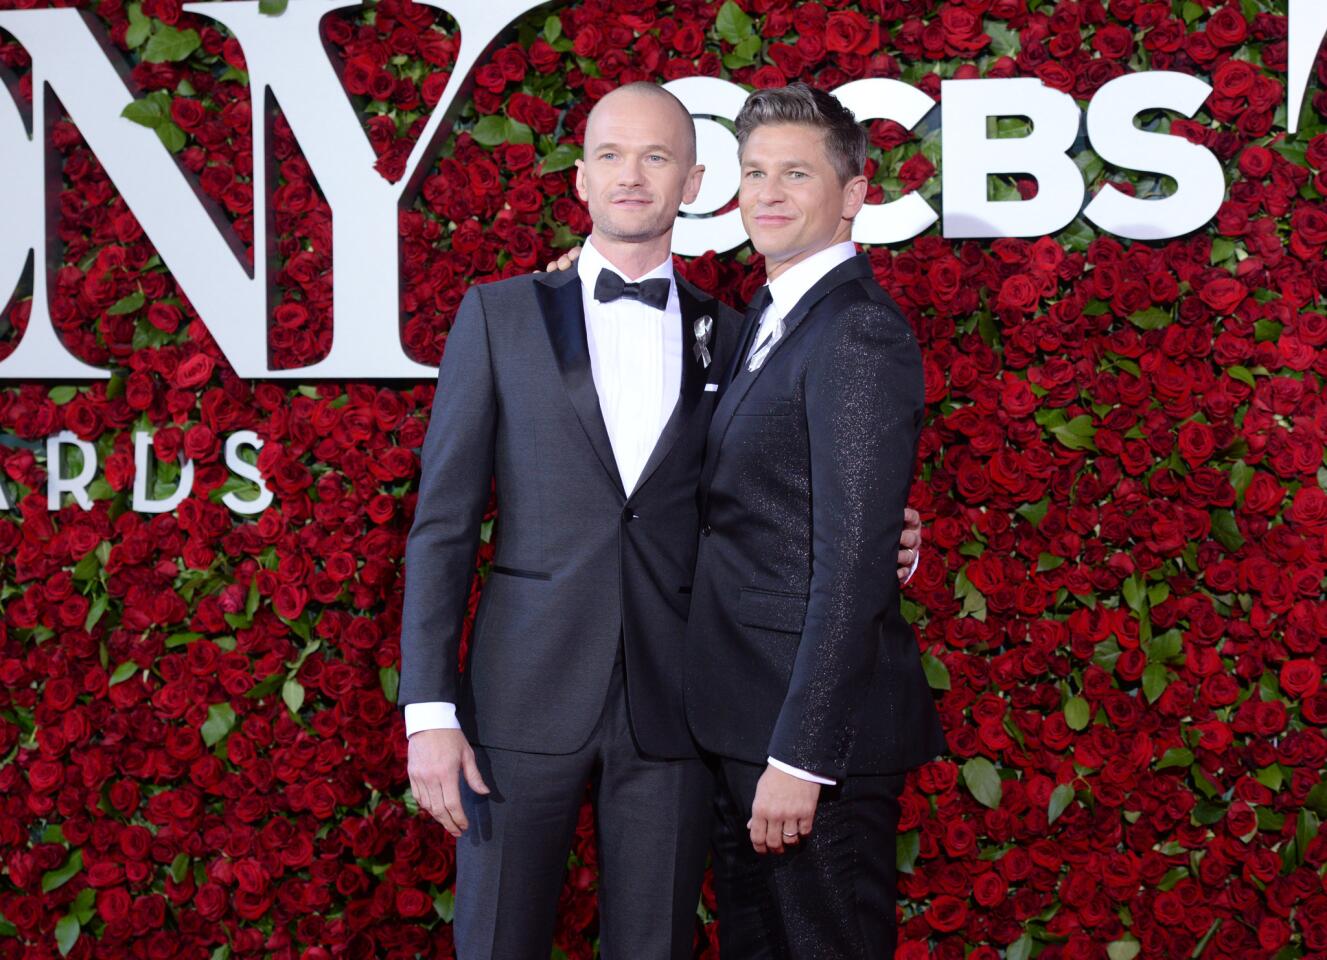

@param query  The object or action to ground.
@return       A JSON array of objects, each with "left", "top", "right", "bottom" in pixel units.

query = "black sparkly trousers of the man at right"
[{"left": 711, "top": 758, "right": 905, "bottom": 960}]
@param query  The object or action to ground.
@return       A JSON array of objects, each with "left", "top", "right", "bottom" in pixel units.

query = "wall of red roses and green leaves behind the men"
[{"left": 0, "top": 0, "right": 1327, "bottom": 960}]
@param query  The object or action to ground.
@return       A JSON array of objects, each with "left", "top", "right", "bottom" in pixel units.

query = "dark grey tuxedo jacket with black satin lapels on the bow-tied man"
[{"left": 397, "top": 261, "right": 740, "bottom": 757}]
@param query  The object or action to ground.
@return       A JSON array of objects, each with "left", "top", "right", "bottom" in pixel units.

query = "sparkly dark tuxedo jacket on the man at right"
[{"left": 686, "top": 254, "right": 946, "bottom": 778}]
